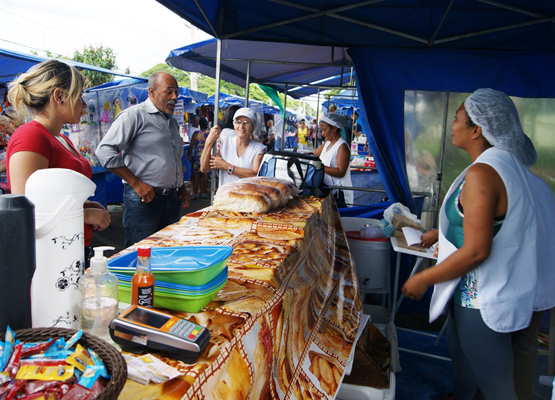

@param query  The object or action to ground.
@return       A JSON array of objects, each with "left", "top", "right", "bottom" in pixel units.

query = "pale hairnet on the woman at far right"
[{"left": 464, "top": 89, "right": 538, "bottom": 168}]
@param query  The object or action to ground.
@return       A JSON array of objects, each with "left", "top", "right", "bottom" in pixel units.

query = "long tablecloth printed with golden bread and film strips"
[{"left": 119, "top": 196, "right": 362, "bottom": 400}]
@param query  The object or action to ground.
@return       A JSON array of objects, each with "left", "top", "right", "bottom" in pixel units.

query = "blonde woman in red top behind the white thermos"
[{"left": 6, "top": 60, "right": 110, "bottom": 265}]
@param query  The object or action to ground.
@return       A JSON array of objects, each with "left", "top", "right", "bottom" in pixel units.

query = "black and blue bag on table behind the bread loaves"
[{"left": 258, "top": 150, "right": 329, "bottom": 197}]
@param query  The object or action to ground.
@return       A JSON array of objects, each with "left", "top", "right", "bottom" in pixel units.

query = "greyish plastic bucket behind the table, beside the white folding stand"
[{"left": 345, "top": 231, "right": 391, "bottom": 289}]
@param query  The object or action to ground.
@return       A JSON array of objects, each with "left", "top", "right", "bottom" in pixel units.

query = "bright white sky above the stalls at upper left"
[{"left": 0, "top": 0, "right": 210, "bottom": 76}]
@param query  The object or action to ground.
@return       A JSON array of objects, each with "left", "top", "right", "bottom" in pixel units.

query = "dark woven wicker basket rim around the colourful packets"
[{"left": 0, "top": 328, "right": 127, "bottom": 400}]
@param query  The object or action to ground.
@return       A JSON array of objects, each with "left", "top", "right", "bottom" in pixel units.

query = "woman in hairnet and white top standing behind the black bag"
[{"left": 312, "top": 113, "right": 354, "bottom": 208}]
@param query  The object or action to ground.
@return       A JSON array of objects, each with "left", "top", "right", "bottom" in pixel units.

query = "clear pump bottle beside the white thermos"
[{"left": 79, "top": 246, "right": 118, "bottom": 343}]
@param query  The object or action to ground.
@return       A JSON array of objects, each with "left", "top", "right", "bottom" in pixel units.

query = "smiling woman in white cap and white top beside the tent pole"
[{"left": 200, "top": 108, "right": 266, "bottom": 186}]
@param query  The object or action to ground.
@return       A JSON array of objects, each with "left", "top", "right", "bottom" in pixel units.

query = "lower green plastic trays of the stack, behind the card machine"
[{"left": 118, "top": 268, "right": 227, "bottom": 313}]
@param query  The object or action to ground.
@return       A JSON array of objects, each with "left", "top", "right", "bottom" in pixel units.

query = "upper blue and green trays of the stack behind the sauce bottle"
[{"left": 108, "top": 246, "right": 233, "bottom": 286}]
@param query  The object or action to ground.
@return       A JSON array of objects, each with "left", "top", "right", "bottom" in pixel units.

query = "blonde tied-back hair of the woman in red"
[{"left": 8, "top": 60, "right": 87, "bottom": 114}]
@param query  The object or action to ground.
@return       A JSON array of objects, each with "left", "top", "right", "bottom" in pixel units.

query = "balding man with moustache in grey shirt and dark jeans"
[{"left": 96, "top": 71, "right": 189, "bottom": 247}]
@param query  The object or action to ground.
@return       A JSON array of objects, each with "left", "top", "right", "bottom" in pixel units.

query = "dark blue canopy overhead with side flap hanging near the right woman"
[{"left": 154, "top": 0, "right": 555, "bottom": 208}]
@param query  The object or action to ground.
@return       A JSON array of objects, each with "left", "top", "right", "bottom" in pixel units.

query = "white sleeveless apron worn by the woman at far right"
[{"left": 430, "top": 148, "right": 555, "bottom": 332}]
